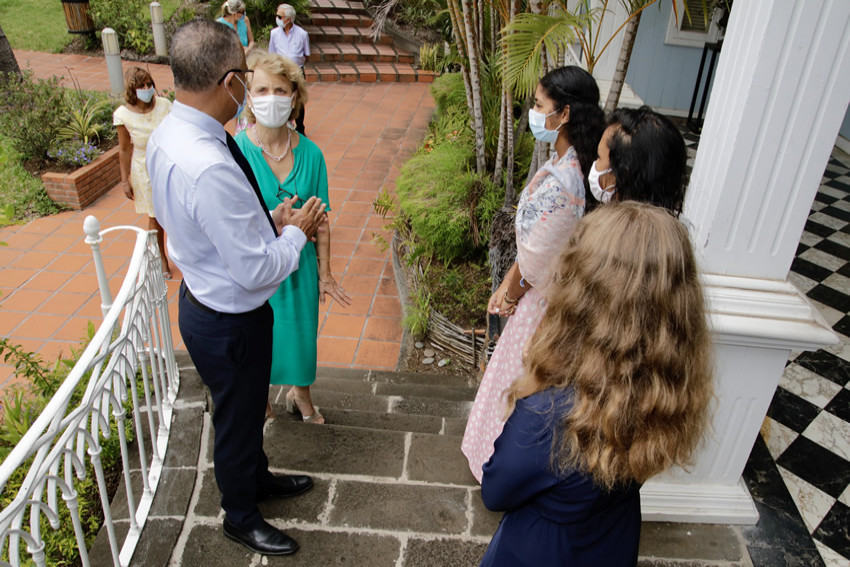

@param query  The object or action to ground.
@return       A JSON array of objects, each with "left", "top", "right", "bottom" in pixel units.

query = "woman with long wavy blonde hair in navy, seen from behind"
[{"left": 481, "top": 202, "right": 713, "bottom": 567}]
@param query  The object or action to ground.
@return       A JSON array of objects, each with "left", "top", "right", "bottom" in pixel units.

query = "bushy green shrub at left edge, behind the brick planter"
[{"left": 0, "top": 69, "right": 68, "bottom": 159}]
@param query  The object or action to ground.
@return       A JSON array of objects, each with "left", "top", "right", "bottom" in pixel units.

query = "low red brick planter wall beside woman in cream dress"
[{"left": 41, "top": 146, "right": 121, "bottom": 210}]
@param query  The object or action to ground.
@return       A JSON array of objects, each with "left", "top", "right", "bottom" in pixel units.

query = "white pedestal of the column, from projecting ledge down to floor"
[{"left": 641, "top": 274, "right": 838, "bottom": 524}]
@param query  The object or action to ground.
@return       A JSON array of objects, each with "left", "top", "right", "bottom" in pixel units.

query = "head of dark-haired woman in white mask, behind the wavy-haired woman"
[{"left": 587, "top": 106, "right": 688, "bottom": 214}]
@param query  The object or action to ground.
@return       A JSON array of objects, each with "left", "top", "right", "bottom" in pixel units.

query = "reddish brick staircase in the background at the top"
[{"left": 303, "top": 0, "right": 436, "bottom": 83}]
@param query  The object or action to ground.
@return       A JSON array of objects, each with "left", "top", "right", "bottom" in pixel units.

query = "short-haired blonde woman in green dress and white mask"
[{"left": 236, "top": 51, "right": 351, "bottom": 423}]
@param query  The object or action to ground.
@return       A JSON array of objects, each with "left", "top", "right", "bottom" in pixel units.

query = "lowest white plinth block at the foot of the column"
[{"left": 640, "top": 479, "right": 759, "bottom": 524}]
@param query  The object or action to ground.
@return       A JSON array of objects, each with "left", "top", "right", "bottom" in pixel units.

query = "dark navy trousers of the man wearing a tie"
[{"left": 178, "top": 284, "right": 274, "bottom": 529}]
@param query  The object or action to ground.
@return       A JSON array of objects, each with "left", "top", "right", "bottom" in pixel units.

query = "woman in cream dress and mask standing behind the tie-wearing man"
[{"left": 112, "top": 67, "right": 171, "bottom": 279}]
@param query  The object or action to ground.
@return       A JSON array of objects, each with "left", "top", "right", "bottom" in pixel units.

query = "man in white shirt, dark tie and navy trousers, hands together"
[{"left": 147, "top": 20, "right": 325, "bottom": 555}]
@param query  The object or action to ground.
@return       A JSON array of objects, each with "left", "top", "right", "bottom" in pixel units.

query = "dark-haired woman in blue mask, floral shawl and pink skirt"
[{"left": 461, "top": 66, "right": 605, "bottom": 481}]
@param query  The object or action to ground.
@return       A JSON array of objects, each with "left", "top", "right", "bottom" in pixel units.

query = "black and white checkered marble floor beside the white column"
[{"left": 685, "top": 143, "right": 850, "bottom": 567}]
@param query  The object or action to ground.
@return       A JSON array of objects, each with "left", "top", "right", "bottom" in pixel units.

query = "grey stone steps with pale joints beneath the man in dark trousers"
[{"left": 114, "top": 353, "right": 753, "bottom": 567}]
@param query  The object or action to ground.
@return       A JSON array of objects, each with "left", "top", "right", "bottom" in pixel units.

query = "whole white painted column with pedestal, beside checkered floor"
[{"left": 642, "top": 0, "right": 850, "bottom": 523}]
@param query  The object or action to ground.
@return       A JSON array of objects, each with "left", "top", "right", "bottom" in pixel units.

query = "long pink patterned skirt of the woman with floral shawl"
[{"left": 461, "top": 288, "right": 546, "bottom": 482}]
